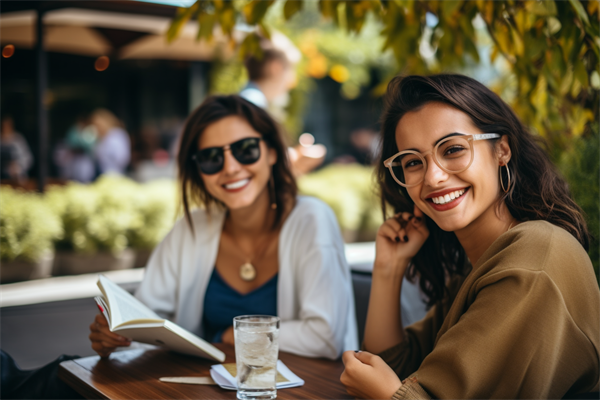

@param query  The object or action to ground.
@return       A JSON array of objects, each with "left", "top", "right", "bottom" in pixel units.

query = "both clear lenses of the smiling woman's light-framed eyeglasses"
[{"left": 392, "top": 136, "right": 472, "bottom": 186}]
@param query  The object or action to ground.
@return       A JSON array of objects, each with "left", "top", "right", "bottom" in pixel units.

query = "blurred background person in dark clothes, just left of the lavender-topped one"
[{"left": 54, "top": 115, "right": 98, "bottom": 183}]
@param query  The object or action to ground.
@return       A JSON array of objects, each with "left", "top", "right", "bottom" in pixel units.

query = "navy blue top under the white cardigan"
[{"left": 202, "top": 268, "right": 278, "bottom": 343}]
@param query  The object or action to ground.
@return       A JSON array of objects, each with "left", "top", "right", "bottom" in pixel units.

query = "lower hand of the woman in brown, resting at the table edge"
[{"left": 340, "top": 351, "right": 402, "bottom": 400}]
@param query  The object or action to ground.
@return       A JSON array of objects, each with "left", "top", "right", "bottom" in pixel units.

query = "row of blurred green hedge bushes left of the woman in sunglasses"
[{"left": 0, "top": 176, "right": 177, "bottom": 260}]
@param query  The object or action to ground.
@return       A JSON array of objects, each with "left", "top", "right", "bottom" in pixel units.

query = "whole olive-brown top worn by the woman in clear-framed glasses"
[{"left": 380, "top": 221, "right": 600, "bottom": 400}]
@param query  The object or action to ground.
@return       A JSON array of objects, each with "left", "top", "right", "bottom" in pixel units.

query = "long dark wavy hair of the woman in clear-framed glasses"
[{"left": 377, "top": 74, "right": 590, "bottom": 305}]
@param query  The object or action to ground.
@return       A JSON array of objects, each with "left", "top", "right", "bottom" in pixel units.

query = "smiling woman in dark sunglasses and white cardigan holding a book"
[{"left": 90, "top": 96, "right": 357, "bottom": 359}]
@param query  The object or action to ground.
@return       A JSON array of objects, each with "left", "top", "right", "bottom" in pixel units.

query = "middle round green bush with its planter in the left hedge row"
[{"left": 47, "top": 176, "right": 137, "bottom": 275}]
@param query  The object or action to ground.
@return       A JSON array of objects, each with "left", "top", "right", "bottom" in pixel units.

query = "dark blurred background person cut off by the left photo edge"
[{"left": 0, "top": 115, "right": 33, "bottom": 181}]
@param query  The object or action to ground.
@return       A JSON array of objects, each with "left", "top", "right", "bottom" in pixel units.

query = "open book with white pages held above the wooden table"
[{"left": 95, "top": 275, "right": 225, "bottom": 362}]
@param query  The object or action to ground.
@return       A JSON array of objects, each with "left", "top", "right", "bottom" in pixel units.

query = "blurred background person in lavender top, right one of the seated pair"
[{"left": 90, "top": 108, "right": 131, "bottom": 175}]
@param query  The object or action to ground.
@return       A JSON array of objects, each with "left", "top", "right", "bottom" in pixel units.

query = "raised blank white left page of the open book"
[{"left": 98, "top": 275, "right": 163, "bottom": 329}]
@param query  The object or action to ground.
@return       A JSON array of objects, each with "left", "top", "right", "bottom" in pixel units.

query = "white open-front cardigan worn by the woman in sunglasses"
[{"left": 136, "top": 196, "right": 358, "bottom": 359}]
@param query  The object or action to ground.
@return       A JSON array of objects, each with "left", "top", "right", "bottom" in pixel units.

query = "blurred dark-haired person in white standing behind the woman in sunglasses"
[{"left": 240, "top": 32, "right": 327, "bottom": 177}]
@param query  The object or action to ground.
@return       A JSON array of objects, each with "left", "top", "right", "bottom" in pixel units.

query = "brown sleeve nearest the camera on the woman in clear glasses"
[{"left": 395, "top": 270, "right": 594, "bottom": 399}]
